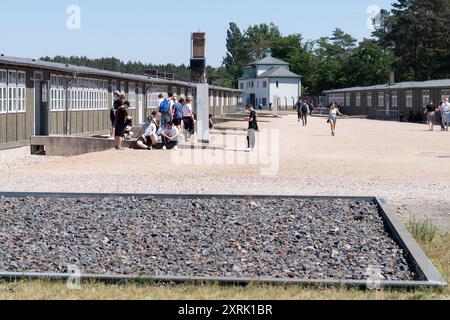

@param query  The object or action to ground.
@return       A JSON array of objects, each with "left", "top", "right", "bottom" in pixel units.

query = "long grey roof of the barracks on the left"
[{"left": 0, "top": 55, "right": 242, "bottom": 92}]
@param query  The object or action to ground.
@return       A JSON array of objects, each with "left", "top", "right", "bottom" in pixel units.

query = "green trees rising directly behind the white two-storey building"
[{"left": 221, "top": 23, "right": 393, "bottom": 95}]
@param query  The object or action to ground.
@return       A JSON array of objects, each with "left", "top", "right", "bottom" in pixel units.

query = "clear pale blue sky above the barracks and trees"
[{"left": 0, "top": 0, "right": 394, "bottom": 66}]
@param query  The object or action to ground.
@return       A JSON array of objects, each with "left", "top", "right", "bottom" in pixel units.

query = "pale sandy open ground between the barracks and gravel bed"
[{"left": 0, "top": 115, "right": 450, "bottom": 231}]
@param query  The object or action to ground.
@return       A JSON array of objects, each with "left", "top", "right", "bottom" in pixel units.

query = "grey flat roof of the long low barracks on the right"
[{"left": 324, "top": 79, "right": 450, "bottom": 94}]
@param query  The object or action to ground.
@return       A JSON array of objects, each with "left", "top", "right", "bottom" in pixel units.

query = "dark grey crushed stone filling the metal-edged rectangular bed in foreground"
[{"left": 0, "top": 197, "right": 414, "bottom": 280}]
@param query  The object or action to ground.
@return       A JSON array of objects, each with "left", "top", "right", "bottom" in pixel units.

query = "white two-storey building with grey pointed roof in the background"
[{"left": 238, "top": 49, "right": 301, "bottom": 109}]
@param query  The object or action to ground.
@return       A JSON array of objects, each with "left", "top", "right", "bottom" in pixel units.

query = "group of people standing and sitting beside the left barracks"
[{"left": 110, "top": 90, "right": 196, "bottom": 150}]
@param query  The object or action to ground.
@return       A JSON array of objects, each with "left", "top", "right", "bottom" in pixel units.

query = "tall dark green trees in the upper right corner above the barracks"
[{"left": 373, "top": 0, "right": 450, "bottom": 81}]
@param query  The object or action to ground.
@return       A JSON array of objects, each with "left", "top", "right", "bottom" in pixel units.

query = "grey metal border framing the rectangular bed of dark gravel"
[{"left": 0, "top": 192, "right": 447, "bottom": 288}]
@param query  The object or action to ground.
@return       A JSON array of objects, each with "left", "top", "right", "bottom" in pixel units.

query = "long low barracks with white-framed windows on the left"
[{"left": 0, "top": 55, "right": 242, "bottom": 149}]
